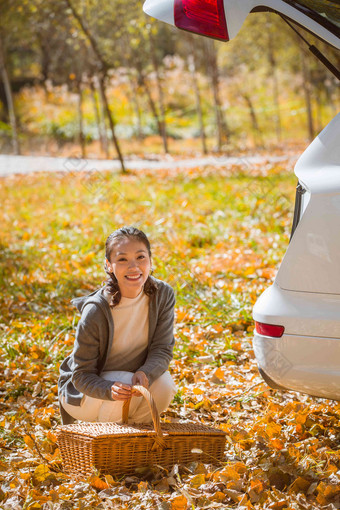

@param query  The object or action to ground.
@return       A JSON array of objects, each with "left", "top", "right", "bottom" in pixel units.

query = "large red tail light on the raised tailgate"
[{"left": 174, "top": 0, "right": 229, "bottom": 41}]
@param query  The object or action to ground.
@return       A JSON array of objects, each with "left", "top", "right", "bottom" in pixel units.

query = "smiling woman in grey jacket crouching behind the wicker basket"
[{"left": 58, "top": 227, "right": 176, "bottom": 423}]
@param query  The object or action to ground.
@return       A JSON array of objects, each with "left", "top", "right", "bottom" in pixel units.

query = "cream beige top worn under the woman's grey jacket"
[{"left": 104, "top": 291, "right": 149, "bottom": 371}]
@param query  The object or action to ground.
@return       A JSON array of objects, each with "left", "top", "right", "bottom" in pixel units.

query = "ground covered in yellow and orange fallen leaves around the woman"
[{"left": 0, "top": 157, "right": 340, "bottom": 510}]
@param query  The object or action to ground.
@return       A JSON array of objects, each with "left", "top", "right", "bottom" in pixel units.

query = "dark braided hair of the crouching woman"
[{"left": 104, "top": 227, "right": 157, "bottom": 308}]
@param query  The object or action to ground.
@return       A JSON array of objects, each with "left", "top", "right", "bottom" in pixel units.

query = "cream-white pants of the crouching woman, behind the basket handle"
[{"left": 61, "top": 371, "right": 177, "bottom": 423}]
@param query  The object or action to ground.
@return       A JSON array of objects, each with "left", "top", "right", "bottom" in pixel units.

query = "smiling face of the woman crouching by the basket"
[{"left": 106, "top": 237, "right": 151, "bottom": 298}]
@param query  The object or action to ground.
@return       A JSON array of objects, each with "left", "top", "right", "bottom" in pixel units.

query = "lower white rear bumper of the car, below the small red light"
[{"left": 253, "top": 332, "right": 340, "bottom": 400}]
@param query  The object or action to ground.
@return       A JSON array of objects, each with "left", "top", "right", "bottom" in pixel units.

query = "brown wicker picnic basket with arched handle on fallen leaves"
[{"left": 57, "top": 386, "right": 225, "bottom": 477}]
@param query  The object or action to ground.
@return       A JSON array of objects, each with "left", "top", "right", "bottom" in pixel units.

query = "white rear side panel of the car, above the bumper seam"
[{"left": 275, "top": 114, "right": 340, "bottom": 294}]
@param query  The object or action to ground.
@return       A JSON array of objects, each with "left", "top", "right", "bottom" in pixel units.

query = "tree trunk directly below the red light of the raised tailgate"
[{"left": 205, "top": 39, "right": 230, "bottom": 151}]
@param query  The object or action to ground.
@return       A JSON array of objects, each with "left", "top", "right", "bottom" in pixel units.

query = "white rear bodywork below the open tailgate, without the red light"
[{"left": 253, "top": 114, "right": 340, "bottom": 400}]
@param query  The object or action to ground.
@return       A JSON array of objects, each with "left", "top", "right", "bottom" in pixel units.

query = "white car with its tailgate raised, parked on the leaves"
[{"left": 144, "top": 0, "right": 340, "bottom": 400}]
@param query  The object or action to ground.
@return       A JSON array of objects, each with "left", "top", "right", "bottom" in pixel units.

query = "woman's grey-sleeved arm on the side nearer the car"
[{"left": 138, "top": 286, "right": 175, "bottom": 385}]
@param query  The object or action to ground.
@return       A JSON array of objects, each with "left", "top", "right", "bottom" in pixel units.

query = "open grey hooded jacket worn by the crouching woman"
[{"left": 58, "top": 276, "right": 175, "bottom": 424}]
